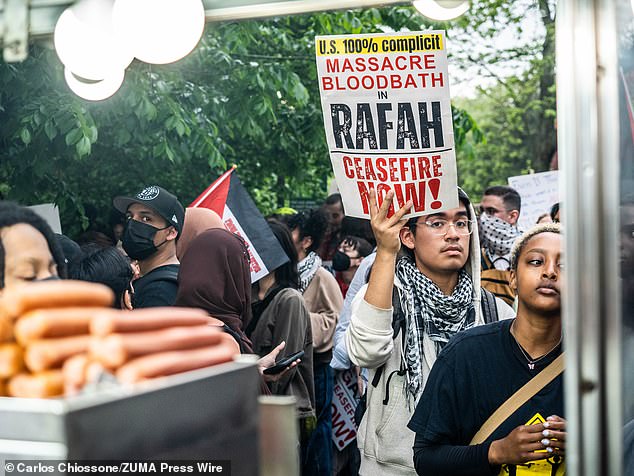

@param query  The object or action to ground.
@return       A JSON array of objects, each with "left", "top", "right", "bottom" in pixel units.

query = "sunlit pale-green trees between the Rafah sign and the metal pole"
[{"left": 451, "top": 0, "right": 556, "bottom": 197}]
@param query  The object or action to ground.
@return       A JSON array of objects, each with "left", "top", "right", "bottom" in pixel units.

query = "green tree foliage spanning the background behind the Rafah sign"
[{"left": 0, "top": 0, "right": 554, "bottom": 236}]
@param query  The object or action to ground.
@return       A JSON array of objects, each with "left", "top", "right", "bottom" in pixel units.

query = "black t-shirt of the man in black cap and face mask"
[{"left": 132, "top": 264, "right": 180, "bottom": 309}]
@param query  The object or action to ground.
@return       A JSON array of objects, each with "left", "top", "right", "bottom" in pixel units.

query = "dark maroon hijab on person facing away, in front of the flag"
[{"left": 176, "top": 227, "right": 253, "bottom": 354}]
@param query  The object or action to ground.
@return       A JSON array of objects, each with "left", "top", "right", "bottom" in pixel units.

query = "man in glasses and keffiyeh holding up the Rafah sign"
[{"left": 345, "top": 190, "right": 513, "bottom": 476}]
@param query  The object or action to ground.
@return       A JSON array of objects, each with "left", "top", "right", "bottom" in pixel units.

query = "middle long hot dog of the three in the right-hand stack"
[{"left": 90, "top": 325, "right": 223, "bottom": 368}]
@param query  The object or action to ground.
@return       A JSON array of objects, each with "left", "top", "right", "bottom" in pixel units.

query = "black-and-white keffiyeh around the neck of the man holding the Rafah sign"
[{"left": 396, "top": 257, "right": 475, "bottom": 401}]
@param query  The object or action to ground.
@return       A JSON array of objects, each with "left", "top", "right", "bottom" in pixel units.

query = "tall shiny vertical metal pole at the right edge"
[{"left": 557, "top": 0, "right": 622, "bottom": 476}]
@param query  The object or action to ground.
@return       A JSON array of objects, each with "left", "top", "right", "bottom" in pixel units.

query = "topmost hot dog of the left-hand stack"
[{"left": 3, "top": 280, "right": 114, "bottom": 319}]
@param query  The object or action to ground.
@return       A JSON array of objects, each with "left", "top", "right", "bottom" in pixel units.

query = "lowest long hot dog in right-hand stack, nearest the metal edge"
[{"left": 116, "top": 334, "right": 239, "bottom": 383}]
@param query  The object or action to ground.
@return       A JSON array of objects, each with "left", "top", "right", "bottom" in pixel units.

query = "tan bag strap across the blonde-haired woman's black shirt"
[{"left": 469, "top": 352, "right": 565, "bottom": 445}]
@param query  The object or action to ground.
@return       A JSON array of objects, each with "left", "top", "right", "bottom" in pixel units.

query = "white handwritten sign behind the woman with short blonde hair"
[{"left": 508, "top": 170, "right": 559, "bottom": 230}]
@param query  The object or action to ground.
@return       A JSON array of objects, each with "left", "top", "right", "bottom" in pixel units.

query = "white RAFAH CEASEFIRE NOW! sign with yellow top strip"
[{"left": 315, "top": 27, "right": 458, "bottom": 218}]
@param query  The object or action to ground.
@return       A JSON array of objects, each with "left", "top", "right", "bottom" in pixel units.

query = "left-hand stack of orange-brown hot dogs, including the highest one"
[{"left": 0, "top": 281, "right": 114, "bottom": 398}]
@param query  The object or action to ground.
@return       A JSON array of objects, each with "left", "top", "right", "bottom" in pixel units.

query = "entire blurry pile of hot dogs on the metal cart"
[{"left": 0, "top": 281, "right": 240, "bottom": 398}]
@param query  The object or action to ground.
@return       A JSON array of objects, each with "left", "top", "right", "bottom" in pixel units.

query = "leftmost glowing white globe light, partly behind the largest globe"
[{"left": 54, "top": 0, "right": 134, "bottom": 80}]
